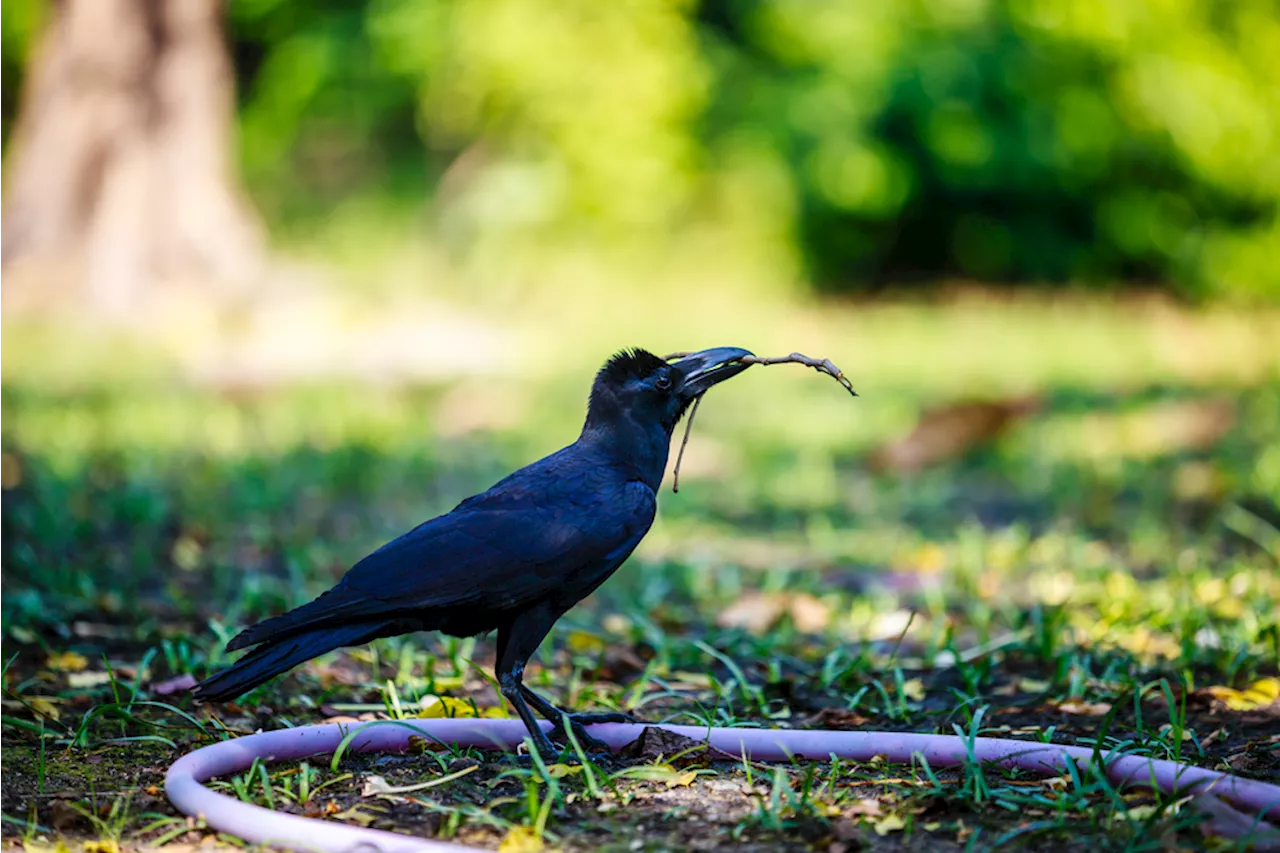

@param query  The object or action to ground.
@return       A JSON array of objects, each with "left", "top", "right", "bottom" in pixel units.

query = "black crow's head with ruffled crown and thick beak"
[{"left": 586, "top": 347, "right": 751, "bottom": 432}]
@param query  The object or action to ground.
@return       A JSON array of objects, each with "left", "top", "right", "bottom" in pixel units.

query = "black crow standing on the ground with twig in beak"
[{"left": 193, "top": 347, "right": 751, "bottom": 754}]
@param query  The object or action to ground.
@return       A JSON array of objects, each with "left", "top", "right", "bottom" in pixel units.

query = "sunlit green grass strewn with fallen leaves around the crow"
[{"left": 0, "top": 290, "right": 1280, "bottom": 850}]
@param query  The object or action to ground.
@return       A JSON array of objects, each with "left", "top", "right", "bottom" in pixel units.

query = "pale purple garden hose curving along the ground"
[{"left": 165, "top": 719, "right": 1280, "bottom": 853}]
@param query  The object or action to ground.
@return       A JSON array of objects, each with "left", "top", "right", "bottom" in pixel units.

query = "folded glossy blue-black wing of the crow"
[{"left": 228, "top": 466, "right": 657, "bottom": 649}]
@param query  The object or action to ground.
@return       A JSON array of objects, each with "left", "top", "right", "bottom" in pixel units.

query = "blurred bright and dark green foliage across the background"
[{"left": 0, "top": 0, "right": 1280, "bottom": 297}]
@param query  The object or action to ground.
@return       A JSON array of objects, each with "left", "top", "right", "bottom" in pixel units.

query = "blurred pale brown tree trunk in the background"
[{"left": 0, "top": 0, "right": 262, "bottom": 314}]
